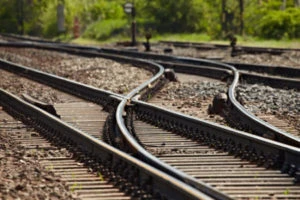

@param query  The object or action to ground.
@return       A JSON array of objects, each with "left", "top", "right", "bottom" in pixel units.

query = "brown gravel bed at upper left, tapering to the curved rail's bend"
[{"left": 0, "top": 47, "right": 153, "bottom": 94}]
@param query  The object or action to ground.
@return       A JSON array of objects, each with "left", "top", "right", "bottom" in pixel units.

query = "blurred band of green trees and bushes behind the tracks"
[{"left": 0, "top": 0, "right": 300, "bottom": 41}]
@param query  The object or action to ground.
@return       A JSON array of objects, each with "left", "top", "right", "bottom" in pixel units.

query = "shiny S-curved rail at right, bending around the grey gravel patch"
[{"left": 82, "top": 49, "right": 300, "bottom": 147}]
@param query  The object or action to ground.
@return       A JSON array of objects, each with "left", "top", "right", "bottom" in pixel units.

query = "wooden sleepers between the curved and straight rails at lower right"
[{"left": 132, "top": 119, "right": 300, "bottom": 199}]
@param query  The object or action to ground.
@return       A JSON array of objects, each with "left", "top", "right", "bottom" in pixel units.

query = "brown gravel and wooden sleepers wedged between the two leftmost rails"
[{"left": 0, "top": 66, "right": 109, "bottom": 140}]
